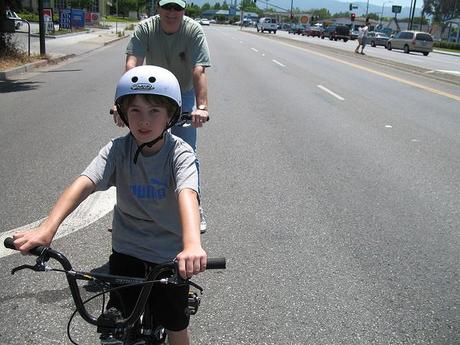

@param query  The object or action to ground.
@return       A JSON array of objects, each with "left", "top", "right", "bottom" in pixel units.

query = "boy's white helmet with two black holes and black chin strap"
[{"left": 115, "top": 65, "right": 182, "bottom": 164}]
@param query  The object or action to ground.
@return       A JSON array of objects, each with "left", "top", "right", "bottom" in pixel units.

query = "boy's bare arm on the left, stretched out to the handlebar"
[{"left": 13, "top": 176, "right": 96, "bottom": 253}]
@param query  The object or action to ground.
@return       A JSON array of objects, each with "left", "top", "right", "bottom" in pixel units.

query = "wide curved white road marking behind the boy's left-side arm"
[{"left": 0, "top": 188, "right": 116, "bottom": 258}]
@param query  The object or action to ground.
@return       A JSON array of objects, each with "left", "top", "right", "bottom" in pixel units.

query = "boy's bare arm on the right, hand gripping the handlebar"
[{"left": 176, "top": 188, "right": 207, "bottom": 279}]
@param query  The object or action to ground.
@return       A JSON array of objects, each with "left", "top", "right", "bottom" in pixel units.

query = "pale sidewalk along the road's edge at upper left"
[{"left": 0, "top": 28, "right": 129, "bottom": 80}]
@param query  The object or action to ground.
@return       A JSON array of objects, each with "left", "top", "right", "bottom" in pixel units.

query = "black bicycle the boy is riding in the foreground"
[{"left": 4, "top": 237, "right": 226, "bottom": 345}]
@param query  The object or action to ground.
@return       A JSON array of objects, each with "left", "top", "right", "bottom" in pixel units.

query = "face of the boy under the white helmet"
[{"left": 126, "top": 95, "right": 169, "bottom": 147}]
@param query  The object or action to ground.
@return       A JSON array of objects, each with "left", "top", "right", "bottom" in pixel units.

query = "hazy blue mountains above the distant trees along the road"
[{"left": 189, "top": 0, "right": 421, "bottom": 18}]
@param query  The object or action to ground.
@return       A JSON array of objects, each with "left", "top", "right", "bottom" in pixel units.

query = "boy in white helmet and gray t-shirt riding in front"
[{"left": 13, "top": 66, "right": 207, "bottom": 345}]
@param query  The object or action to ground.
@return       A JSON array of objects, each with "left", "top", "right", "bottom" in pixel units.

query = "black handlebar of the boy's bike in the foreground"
[{"left": 4, "top": 237, "right": 226, "bottom": 327}]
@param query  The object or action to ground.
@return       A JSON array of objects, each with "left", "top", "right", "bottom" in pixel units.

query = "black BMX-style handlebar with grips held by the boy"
[{"left": 4, "top": 237, "right": 226, "bottom": 328}]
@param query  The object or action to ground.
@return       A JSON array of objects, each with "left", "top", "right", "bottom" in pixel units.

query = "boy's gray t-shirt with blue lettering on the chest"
[{"left": 82, "top": 133, "right": 198, "bottom": 263}]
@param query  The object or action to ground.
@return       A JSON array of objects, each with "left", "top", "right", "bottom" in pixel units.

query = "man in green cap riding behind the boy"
[{"left": 114, "top": 0, "right": 211, "bottom": 232}]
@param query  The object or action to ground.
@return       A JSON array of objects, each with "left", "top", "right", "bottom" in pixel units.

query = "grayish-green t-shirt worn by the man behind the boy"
[{"left": 126, "top": 15, "right": 211, "bottom": 92}]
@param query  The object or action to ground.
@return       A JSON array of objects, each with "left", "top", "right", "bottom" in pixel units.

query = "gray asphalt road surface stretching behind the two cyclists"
[{"left": 0, "top": 26, "right": 460, "bottom": 345}]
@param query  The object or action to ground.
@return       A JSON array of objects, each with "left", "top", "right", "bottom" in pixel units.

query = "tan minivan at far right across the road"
[{"left": 386, "top": 31, "right": 433, "bottom": 56}]
